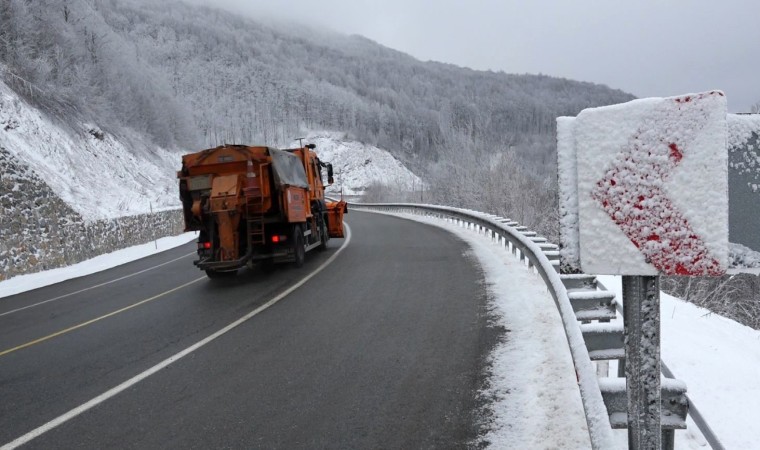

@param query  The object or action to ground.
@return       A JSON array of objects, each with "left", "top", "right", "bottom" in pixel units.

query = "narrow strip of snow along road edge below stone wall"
[{"left": 0, "top": 232, "right": 197, "bottom": 299}]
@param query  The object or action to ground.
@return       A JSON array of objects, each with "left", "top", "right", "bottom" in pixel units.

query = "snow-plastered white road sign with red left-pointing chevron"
[{"left": 557, "top": 91, "right": 728, "bottom": 276}]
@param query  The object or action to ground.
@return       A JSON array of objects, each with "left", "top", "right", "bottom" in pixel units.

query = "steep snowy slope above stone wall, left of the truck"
[{"left": 0, "top": 82, "right": 179, "bottom": 221}]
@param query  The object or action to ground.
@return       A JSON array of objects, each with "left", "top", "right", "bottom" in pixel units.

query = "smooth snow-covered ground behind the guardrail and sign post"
[{"left": 598, "top": 276, "right": 760, "bottom": 449}]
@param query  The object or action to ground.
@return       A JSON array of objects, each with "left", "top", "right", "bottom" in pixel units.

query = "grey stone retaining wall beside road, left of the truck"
[{"left": 0, "top": 147, "right": 183, "bottom": 280}]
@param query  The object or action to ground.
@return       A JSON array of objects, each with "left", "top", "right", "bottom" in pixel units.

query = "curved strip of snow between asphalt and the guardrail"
[{"left": 380, "top": 214, "right": 591, "bottom": 449}]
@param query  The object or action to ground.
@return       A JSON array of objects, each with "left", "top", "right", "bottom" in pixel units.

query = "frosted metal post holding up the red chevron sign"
[{"left": 623, "top": 276, "right": 663, "bottom": 450}]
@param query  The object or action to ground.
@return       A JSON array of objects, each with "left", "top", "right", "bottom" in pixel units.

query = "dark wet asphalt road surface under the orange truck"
[{"left": 0, "top": 211, "right": 496, "bottom": 449}]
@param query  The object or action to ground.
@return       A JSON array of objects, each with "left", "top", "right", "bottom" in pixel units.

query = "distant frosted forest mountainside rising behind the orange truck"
[{"left": 102, "top": 1, "right": 632, "bottom": 165}]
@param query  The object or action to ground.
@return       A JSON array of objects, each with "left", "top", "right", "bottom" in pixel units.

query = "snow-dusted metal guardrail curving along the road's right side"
[{"left": 350, "top": 203, "right": 620, "bottom": 449}]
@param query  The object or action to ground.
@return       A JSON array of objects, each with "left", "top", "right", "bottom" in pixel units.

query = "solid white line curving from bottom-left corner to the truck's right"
[{"left": 0, "top": 222, "right": 351, "bottom": 450}]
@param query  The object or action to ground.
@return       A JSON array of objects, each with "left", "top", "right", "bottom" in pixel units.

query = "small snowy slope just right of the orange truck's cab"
[{"left": 306, "top": 132, "right": 422, "bottom": 196}]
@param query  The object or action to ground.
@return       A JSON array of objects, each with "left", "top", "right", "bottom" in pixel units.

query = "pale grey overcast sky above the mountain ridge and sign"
[{"left": 191, "top": 0, "right": 760, "bottom": 112}]
